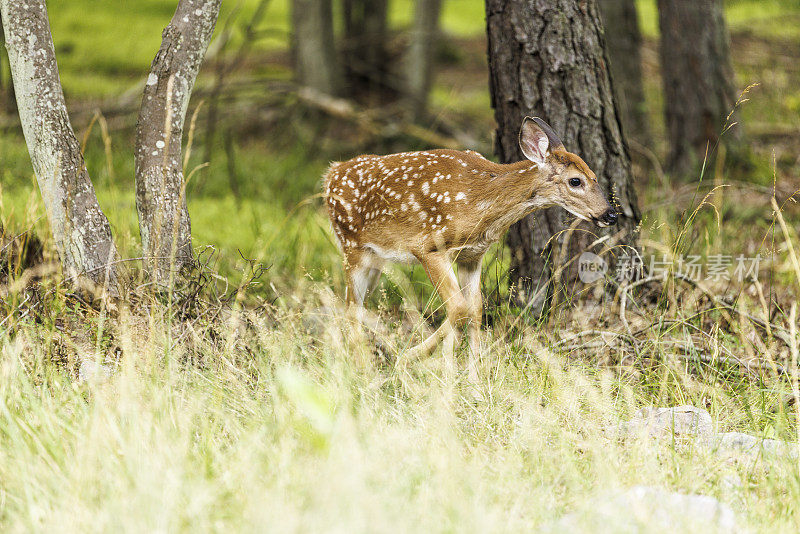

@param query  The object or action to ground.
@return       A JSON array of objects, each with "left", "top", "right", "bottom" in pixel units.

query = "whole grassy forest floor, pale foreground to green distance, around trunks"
[{"left": 0, "top": 0, "right": 800, "bottom": 532}]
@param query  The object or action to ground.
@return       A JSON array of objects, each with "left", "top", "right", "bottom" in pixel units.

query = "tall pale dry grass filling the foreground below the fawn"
[{"left": 0, "top": 258, "right": 800, "bottom": 532}]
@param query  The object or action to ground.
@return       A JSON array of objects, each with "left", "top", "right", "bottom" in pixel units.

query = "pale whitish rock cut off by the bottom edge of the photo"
[{"left": 542, "top": 486, "right": 746, "bottom": 534}]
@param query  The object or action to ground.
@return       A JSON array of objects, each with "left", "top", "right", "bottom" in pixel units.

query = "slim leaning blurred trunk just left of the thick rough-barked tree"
[{"left": 404, "top": 0, "right": 442, "bottom": 121}]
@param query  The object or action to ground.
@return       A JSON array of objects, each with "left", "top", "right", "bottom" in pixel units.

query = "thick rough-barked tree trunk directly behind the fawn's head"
[{"left": 486, "top": 0, "right": 640, "bottom": 311}]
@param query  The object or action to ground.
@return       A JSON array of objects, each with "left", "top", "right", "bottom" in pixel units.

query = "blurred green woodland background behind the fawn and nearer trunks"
[{"left": 0, "top": 0, "right": 800, "bottom": 306}]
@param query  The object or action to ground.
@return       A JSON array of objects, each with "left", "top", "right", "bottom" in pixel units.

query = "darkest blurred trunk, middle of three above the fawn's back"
[{"left": 343, "top": 0, "right": 388, "bottom": 98}]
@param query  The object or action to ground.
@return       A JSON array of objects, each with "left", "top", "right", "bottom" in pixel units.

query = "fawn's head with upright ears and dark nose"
[{"left": 519, "top": 117, "right": 617, "bottom": 226}]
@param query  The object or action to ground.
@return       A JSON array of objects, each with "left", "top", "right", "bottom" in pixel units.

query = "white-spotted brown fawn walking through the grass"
[{"left": 324, "top": 117, "right": 617, "bottom": 381}]
